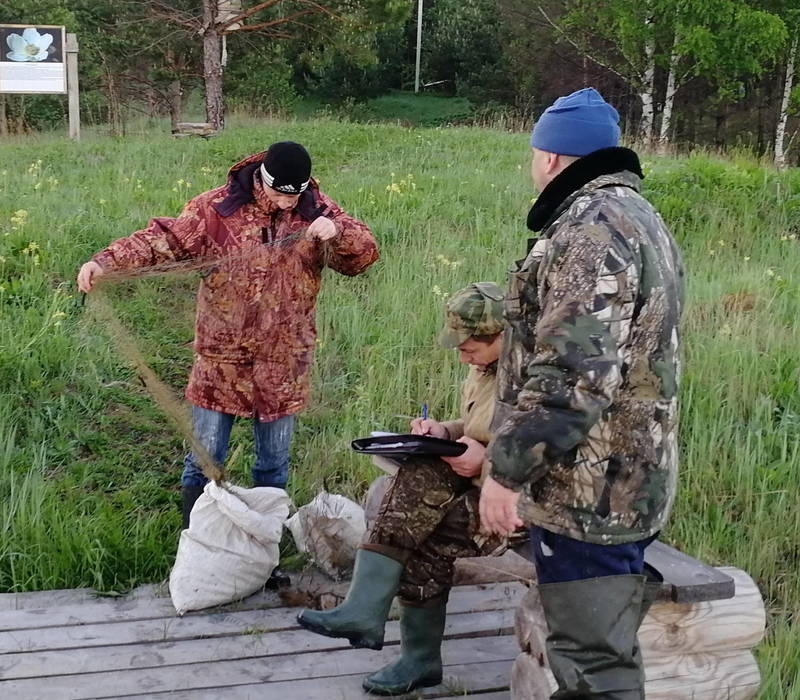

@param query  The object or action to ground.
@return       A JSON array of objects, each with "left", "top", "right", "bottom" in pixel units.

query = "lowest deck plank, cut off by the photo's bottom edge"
[{"left": 95, "top": 661, "right": 510, "bottom": 700}]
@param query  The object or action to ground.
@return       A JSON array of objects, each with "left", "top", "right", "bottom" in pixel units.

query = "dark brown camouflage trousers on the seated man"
[{"left": 367, "top": 458, "right": 508, "bottom": 605}]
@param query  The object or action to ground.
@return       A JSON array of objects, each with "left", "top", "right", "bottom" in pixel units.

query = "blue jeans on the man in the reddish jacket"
[{"left": 181, "top": 406, "right": 295, "bottom": 489}]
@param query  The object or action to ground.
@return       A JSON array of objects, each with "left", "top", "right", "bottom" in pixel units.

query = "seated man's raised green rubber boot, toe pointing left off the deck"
[{"left": 297, "top": 549, "right": 403, "bottom": 649}]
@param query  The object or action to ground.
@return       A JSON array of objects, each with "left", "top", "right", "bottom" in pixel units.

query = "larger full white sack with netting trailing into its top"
[{"left": 169, "top": 481, "right": 289, "bottom": 615}]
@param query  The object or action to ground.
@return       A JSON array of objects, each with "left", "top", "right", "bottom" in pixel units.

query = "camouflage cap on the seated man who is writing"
[{"left": 439, "top": 282, "right": 504, "bottom": 348}]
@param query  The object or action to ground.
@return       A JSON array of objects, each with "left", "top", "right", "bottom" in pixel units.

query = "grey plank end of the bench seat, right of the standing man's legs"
[{"left": 644, "top": 540, "right": 735, "bottom": 603}]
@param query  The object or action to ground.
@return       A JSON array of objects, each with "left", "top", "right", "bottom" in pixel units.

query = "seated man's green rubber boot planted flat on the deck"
[{"left": 361, "top": 597, "right": 447, "bottom": 695}]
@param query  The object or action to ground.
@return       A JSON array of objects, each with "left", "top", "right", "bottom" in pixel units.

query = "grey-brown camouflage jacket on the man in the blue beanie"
[{"left": 489, "top": 149, "right": 683, "bottom": 544}]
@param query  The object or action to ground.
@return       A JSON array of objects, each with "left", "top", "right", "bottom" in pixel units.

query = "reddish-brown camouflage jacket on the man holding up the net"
[{"left": 93, "top": 153, "right": 378, "bottom": 421}]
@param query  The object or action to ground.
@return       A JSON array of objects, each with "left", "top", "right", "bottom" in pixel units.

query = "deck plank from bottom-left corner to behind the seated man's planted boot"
[{"left": 0, "top": 635, "right": 517, "bottom": 700}]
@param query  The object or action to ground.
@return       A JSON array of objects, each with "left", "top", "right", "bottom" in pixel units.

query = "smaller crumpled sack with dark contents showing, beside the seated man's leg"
[{"left": 286, "top": 491, "right": 367, "bottom": 579}]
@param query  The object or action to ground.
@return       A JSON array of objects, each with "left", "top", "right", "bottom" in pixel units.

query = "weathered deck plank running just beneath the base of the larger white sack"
[{"left": 0, "top": 583, "right": 526, "bottom": 632}]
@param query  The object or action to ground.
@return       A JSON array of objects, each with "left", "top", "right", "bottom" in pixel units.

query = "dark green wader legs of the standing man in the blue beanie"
[{"left": 539, "top": 575, "right": 645, "bottom": 700}]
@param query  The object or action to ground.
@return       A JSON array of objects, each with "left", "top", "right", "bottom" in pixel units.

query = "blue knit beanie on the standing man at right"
[{"left": 531, "top": 88, "right": 620, "bottom": 157}]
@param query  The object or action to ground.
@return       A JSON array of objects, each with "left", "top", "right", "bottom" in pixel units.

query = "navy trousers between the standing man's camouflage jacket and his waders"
[{"left": 530, "top": 525, "right": 658, "bottom": 584}]
